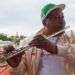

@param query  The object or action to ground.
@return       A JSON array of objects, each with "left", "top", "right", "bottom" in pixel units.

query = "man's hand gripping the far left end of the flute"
[{"left": 4, "top": 45, "right": 22, "bottom": 67}]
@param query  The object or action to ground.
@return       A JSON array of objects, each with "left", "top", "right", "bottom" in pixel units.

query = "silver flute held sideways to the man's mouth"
[{"left": 0, "top": 26, "right": 70, "bottom": 63}]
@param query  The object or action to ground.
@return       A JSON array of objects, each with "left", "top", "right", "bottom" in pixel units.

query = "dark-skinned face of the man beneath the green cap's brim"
[{"left": 46, "top": 9, "right": 65, "bottom": 32}]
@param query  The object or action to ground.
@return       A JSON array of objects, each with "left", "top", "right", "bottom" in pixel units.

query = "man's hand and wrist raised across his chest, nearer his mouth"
[{"left": 29, "top": 35, "right": 57, "bottom": 54}]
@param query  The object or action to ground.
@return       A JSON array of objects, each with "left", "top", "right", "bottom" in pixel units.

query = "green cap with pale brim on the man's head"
[{"left": 41, "top": 4, "right": 65, "bottom": 20}]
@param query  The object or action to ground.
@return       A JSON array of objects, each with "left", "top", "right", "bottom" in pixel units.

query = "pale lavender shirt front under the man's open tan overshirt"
[{"left": 38, "top": 38, "right": 67, "bottom": 75}]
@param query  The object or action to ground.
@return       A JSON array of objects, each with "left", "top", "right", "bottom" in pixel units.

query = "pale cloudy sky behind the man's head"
[{"left": 0, "top": 0, "right": 75, "bottom": 36}]
